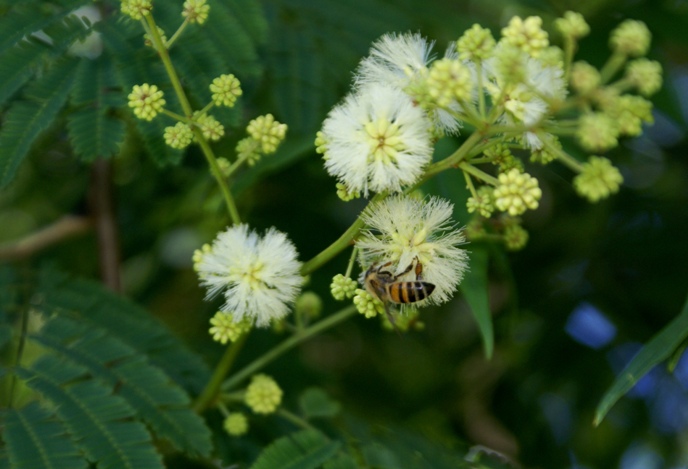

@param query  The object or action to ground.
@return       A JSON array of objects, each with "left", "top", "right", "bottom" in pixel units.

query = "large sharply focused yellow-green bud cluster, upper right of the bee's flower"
[{"left": 494, "top": 169, "right": 542, "bottom": 216}]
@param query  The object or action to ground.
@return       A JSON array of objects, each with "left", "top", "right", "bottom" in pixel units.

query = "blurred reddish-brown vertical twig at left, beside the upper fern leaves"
[{"left": 89, "top": 158, "right": 121, "bottom": 292}]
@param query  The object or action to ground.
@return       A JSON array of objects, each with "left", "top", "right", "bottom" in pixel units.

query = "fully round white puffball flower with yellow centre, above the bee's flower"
[{"left": 322, "top": 84, "right": 433, "bottom": 196}]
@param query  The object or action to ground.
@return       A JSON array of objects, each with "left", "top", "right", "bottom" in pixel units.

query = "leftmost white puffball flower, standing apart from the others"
[{"left": 195, "top": 224, "right": 303, "bottom": 327}]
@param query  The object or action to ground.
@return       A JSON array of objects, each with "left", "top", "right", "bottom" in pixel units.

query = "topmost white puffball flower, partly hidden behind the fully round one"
[{"left": 354, "top": 33, "right": 461, "bottom": 135}]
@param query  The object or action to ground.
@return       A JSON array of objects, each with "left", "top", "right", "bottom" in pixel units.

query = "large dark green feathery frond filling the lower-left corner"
[{"left": 2, "top": 270, "right": 212, "bottom": 468}]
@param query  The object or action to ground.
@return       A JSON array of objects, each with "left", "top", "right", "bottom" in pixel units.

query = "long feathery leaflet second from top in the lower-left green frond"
[{"left": 33, "top": 315, "right": 212, "bottom": 456}]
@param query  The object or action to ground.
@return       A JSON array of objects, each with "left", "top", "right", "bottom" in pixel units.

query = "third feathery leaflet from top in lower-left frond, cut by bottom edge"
[{"left": 15, "top": 355, "right": 163, "bottom": 469}]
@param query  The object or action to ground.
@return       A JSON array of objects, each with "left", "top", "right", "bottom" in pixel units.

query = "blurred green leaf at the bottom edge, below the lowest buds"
[{"left": 251, "top": 430, "right": 341, "bottom": 469}]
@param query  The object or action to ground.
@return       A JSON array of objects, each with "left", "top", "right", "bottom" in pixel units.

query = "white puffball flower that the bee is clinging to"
[{"left": 356, "top": 195, "right": 468, "bottom": 304}]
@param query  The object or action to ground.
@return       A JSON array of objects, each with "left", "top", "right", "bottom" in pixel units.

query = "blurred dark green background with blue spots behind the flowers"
[{"left": 0, "top": 0, "right": 688, "bottom": 469}]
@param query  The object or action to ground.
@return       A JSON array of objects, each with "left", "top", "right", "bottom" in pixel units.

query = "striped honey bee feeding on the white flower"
[{"left": 364, "top": 257, "right": 435, "bottom": 308}]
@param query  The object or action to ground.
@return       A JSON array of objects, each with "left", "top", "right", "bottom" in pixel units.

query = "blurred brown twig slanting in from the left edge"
[{"left": 0, "top": 215, "right": 93, "bottom": 261}]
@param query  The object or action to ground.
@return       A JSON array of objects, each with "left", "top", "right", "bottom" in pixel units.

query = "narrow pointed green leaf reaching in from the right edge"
[{"left": 594, "top": 288, "right": 688, "bottom": 425}]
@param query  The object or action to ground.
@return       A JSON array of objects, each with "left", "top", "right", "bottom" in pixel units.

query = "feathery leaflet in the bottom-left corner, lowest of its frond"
[{"left": 3, "top": 401, "right": 88, "bottom": 469}]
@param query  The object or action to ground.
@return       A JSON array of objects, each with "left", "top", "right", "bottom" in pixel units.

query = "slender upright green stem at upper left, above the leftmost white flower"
[{"left": 145, "top": 15, "right": 241, "bottom": 224}]
